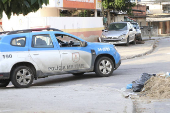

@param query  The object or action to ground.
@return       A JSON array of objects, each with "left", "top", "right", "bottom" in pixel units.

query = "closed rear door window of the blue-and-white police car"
[{"left": 32, "top": 34, "right": 54, "bottom": 48}]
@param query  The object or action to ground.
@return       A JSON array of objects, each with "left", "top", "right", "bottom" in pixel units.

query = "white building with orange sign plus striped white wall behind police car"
[{"left": 2, "top": 0, "right": 104, "bottom": 42}]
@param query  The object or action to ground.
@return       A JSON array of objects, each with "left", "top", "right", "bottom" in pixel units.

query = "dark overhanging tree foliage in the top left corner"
[{"left": 0, "top": 0, "right": 49, "bottom": 18}]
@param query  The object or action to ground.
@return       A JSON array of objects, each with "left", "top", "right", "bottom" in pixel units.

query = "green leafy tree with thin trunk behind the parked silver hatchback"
[{"left": 102, "top": 0, "right": 135, "bottom": 24}]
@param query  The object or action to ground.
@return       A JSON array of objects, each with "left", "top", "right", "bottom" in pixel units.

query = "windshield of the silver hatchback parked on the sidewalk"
[{"left": 108, "top": 23, "right": 127, "bottom": 31}]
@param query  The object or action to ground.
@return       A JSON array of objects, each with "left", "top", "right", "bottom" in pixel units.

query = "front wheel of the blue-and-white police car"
[{"left": 95, "top": 57, "right": 114, "bottom": 77}]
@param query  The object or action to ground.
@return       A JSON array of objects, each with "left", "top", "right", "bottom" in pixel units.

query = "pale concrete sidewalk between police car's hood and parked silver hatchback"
[{"left": 116, "top": 37, "right": 160, "bottom": 60}]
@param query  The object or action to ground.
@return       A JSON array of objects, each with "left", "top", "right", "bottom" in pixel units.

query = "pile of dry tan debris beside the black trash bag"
[{"left": 141, "top": 76, "right": 170, "bottom": 99}]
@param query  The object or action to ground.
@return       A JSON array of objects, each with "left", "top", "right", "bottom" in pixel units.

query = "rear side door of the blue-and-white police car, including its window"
[{"left": 29, "top": 32, "right": 61, "bottom": 74}]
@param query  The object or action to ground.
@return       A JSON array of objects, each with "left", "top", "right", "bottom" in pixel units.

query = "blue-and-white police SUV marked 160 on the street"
[{"left": 0, "top": 28, "right": 121, "bottom": 88}]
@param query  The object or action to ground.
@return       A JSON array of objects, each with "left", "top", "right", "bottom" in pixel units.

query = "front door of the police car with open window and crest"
[{"left": 55, "top": 33, "right": 92, "bottom": 72}]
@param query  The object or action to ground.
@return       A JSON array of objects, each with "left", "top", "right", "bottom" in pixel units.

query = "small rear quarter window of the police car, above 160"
[{"left": 11, "top": 37, "right": 26, "bottom": 47}]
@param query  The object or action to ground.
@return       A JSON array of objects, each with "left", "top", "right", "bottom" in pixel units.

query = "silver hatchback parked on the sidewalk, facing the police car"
[{"left": 99, "top": 22, "right": 136, "bottom": 46}]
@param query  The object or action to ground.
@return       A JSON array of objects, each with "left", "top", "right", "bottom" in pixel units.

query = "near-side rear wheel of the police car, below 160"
[{"left": 11, "top": 66, "right": 34, "bottom": 88}]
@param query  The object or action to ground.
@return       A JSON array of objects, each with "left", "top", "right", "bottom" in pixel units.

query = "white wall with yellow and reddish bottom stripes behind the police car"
[{"left": 2, "top": 16, "right": 104, "bottom": 42}]
